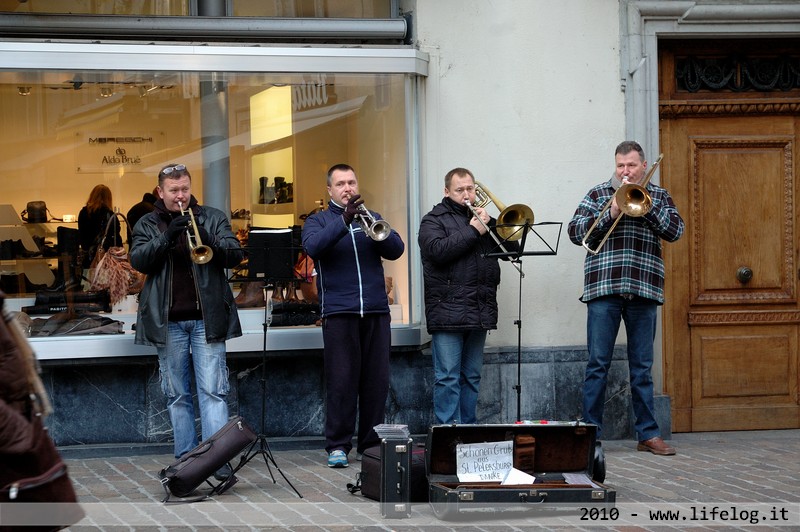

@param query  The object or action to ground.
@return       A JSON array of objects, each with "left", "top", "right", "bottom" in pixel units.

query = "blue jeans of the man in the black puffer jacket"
[{"left": 431, "top": 329, "right": 486, "bottom": 424}]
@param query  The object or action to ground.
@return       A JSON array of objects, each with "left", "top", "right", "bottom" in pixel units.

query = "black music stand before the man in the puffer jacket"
[{"left": 484, "top": 222, "right": 563, "bottom": 421}]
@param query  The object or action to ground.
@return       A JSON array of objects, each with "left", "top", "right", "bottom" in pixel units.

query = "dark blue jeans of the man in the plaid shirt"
[{"left": 583, "top": 296, "right": 661, "bottom": 441}]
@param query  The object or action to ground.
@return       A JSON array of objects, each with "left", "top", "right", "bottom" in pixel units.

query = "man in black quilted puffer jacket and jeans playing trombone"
[{"left": 418, "top": 168, "right": 518, "bottom": 424}]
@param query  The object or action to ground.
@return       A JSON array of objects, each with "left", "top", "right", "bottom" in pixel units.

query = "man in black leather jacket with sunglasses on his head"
[{"left": 130, "top": 164, "right": 244, "bottom": 480}]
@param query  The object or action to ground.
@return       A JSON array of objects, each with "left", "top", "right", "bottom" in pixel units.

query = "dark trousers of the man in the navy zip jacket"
[{"left": 322, "top": 314, "right": 392, "bottom": 453}]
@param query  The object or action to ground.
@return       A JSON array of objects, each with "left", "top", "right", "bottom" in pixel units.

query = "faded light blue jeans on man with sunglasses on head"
[{"left": 157, "top": 320, "right": 230, "bottom": 458}]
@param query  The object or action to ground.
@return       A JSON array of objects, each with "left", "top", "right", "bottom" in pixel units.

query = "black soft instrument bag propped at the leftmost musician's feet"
[{"left": 159, "top": 416, "right": 258, "bottom": 502}]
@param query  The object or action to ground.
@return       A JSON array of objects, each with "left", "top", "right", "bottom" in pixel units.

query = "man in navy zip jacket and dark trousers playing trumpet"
[{"left": 303, "top": 164, "right": 405, "bottom": 467}]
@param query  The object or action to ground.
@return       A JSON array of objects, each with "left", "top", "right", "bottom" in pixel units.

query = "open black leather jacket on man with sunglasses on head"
[{"left": 130, "top": 197, "right": 244, "bottom": 346}]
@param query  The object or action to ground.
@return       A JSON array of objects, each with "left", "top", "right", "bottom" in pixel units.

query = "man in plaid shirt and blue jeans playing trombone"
[{"left": 568, "top": 141, "right": 684, "bottom": 455}]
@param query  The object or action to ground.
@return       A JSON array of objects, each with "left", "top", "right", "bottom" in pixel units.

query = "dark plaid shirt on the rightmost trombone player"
[{"left": 568, "top": 178, "right": 684, "bottom": 304}]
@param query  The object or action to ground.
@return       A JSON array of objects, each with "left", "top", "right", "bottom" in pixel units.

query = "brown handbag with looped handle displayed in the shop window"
[{"left": 89, "top": 213, "right": 145, "bottom": 305}]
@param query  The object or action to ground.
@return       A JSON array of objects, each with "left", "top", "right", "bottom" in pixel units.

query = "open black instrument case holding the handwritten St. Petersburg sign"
[{"left": 425, "top": 422, "right": 616, "bottom": 519}]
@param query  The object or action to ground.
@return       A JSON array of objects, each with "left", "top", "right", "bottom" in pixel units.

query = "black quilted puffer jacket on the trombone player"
[{"left": 418, "top": 197, "right": 517, "bottom": 332}]
